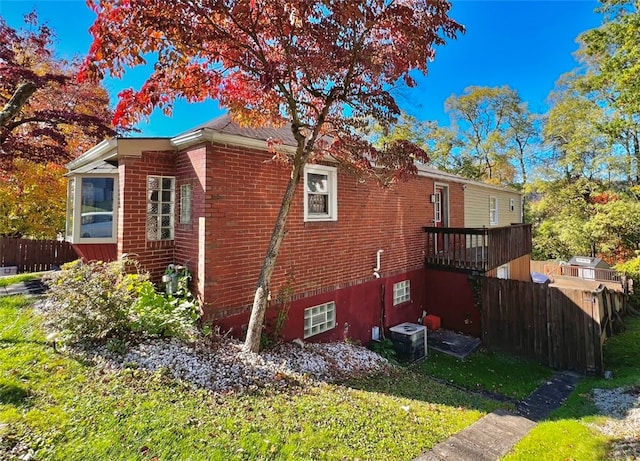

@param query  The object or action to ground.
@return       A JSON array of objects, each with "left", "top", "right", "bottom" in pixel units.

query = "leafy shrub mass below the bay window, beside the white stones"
[{"left": 46, "top": 259, "right": 200, "bottom": 340}]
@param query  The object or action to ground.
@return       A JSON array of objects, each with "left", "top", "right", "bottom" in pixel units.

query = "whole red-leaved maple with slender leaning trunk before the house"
[{"left": 85, "top": 0, "right": 463, "bottom": 352}]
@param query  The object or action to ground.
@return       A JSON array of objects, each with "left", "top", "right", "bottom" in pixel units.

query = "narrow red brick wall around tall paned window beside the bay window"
[{"left": 118, "top": 152, "right": 176, "bottom": 281}]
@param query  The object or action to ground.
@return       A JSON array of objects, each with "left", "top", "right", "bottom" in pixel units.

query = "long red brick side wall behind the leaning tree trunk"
[{"left": 195, "top": 142, "right": 464, "bottom": 326}]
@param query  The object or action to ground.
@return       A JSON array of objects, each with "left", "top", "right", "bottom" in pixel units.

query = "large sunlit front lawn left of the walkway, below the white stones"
[{"left": 0, "top": 296, "right": 510, "bottom": 460}]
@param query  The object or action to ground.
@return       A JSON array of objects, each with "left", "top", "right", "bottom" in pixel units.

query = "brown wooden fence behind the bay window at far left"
[{"left": 0, "top": 238, "right": 78, "bottom": 272}]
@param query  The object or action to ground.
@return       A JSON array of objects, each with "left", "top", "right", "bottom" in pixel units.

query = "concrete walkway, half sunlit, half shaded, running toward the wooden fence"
[{"left": 414, "top": 372, "right": 581, "bottom": 461}]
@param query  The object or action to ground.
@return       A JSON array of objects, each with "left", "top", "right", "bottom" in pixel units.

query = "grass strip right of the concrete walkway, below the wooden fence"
[{"left": 504, "top": 310, "right": 640, "bottom": 461}]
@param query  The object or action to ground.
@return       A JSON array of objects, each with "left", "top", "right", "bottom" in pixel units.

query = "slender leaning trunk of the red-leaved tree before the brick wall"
[{"left": 243, "top": 158, "right": 306, "bottom": 352}]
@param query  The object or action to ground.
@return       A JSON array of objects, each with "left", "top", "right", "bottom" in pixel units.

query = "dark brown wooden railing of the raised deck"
[{"left": 424, "top": 224, "right": 531, "bottom": 272}]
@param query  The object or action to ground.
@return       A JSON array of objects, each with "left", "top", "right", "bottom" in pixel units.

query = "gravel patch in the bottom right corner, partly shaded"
[{"left": 592, "top": 387, "right": 640, "bottom": 461}]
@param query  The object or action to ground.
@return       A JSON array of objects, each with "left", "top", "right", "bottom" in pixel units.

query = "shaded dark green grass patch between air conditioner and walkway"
[{"left": 415, "top": 349, "right": 552, "bottom": 400}]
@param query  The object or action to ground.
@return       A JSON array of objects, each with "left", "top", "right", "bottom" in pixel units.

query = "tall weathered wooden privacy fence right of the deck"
[{"left": 482, "top": 277, "right": 624, "bottom": 373}]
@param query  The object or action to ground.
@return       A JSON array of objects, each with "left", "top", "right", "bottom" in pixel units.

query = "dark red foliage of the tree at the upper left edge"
[{"left": 0, "top": 13, "right": 114, "bottom": 169}]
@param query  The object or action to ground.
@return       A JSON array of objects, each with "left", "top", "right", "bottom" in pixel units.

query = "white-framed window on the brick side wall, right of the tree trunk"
[{"left": 304, "top": 165, "right": 338, "bottom": 221}]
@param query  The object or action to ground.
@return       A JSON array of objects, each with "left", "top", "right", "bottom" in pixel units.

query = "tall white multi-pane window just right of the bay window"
[{"left": 147, "top": 176, "right": 175, "bottom": 240}]
